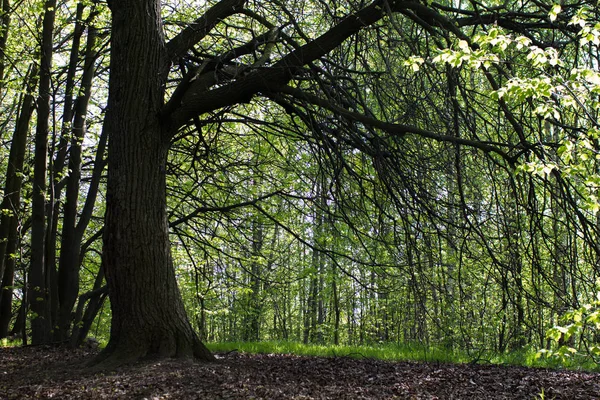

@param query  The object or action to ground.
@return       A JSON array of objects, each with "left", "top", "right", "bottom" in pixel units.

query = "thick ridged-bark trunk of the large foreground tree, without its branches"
[{"left": 92, "top": 0, "right": 213, "bottom": 368}]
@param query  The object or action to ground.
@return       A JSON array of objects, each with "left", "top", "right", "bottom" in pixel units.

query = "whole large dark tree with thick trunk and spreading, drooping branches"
[{"left": 92, "top": 0, "right": 600, "bottom": 365}]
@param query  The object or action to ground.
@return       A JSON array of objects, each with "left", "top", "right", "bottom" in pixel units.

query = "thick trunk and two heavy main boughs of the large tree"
[{"left": 97, "top": 0, "right": 446, "bottom": 366}]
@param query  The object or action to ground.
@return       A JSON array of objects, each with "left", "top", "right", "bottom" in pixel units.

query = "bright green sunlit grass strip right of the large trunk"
[{"left": 206, "top": 341, "right": 600, "bottom": 371}]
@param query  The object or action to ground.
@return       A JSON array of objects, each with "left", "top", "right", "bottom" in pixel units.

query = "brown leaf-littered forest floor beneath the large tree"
[{"left": 0, "top": 347, "right": 600, "bottom": 400}]
